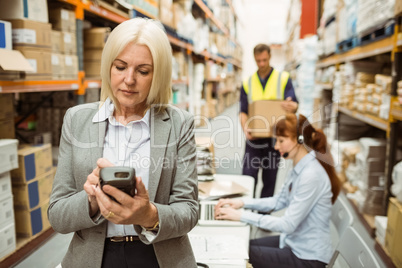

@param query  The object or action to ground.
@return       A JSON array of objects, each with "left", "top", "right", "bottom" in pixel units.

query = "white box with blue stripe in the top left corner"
[{"left": 0, "top": 0, "right": 49, "bottom": 22}]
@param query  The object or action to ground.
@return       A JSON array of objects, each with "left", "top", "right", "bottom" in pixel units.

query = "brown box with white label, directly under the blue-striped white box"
[{"left": 10, "top": 20, "right": 52, "bottom": 50}]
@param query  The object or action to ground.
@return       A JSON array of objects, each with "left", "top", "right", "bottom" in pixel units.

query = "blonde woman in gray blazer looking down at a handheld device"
[{"left": 48, "top": 18, "right": 198, "bottom": 268}]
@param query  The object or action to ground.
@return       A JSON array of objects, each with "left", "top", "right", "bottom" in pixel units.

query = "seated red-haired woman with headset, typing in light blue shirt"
[{"left": 215, "top": 114, "right": 341, "bottom": 268}]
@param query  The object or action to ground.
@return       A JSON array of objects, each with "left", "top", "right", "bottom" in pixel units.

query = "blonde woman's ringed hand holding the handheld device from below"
[{"left": 96, "top": 177, "right": 158, "bottom": 227}]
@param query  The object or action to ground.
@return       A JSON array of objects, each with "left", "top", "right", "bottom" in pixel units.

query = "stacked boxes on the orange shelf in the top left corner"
[{"left": 0, "top": 0, "right": 78, "bottom": 80}]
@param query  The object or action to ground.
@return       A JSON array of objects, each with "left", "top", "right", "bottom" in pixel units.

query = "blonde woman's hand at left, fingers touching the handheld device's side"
[{"left": 84, "top": 158, "right": 113, "bottom": 217}]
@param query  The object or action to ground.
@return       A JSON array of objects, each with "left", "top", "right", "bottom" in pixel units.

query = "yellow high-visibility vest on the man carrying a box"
[{"left": 243, "top": 69, "right": 289, "bottom": 103}]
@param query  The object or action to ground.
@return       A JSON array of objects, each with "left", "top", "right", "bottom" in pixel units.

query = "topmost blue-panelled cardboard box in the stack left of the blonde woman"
[{"left": 11, "top": 143, "right": 53, "bottom": 183}]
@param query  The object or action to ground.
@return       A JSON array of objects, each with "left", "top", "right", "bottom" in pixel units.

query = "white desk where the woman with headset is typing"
[{"left": 189, "top": 174, "right": 254, "bottom": 268}]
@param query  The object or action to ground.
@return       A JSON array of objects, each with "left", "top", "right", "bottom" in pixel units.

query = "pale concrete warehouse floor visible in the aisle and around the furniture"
[{"left": 14, "top": 104, "right": 386, "bottom": 268}]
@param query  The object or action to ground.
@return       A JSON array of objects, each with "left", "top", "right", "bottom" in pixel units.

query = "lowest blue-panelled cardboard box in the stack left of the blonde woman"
[{"left": 14, "top": 200, "right": 50, "bottom": 237}]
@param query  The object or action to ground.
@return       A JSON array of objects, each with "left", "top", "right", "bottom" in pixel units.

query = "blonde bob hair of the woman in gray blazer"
[{"left": 100, "top": 18, "right": 172, "bottom": 111}]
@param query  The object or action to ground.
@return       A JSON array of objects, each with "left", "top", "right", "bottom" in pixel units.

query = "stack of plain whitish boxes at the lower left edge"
[{"left": 0, "top": 139, "right": 18, "bottom": 259}]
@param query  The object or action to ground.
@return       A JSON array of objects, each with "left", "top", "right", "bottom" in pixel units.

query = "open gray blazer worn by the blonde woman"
[{"left": 48, "top": 103, "right": 199, "bottom": 268}]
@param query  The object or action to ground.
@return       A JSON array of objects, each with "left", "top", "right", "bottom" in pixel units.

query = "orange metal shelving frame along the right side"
[{"left": 316, "top": 11, "right": 402, "bottom": 267}]
